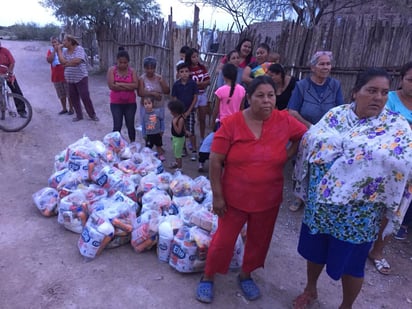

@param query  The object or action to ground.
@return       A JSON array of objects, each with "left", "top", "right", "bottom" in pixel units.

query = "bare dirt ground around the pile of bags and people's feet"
[{"left": 0, "top": 41, "right": 412, "bottom": 309}]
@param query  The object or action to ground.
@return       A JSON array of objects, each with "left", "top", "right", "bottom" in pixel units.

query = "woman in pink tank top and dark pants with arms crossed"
[{"left": 107, "top": 48, "right": 139, "bottom": 142}]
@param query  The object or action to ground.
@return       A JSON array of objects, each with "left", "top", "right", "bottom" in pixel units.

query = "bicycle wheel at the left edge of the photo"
[{"left": 0, "top": 93, "right": 33, "bottom": 132}]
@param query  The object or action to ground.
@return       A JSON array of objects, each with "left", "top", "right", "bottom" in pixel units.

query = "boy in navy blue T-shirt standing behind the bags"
[{"left": 172, "top": 63, "right": 199, "bottom": 161}]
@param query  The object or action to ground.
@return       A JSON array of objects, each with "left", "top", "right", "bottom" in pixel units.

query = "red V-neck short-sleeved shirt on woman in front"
[{"left": 212, "top": 110, "right": 307, "bottom": 212}]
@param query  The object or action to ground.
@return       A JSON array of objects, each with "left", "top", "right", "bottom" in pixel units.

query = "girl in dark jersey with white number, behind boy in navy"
[{"left": 185, "top": 48, "right": 210, "bottom": 154}]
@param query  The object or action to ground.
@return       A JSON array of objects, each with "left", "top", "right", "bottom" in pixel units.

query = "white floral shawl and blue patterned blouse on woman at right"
[{"left": 294, "top": 103, "right": 412, "bottom": 239}]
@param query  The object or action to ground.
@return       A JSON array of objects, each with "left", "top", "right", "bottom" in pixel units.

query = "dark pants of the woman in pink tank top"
[{"left": 110, "top": 103, "right": 137, "bottom": 142}]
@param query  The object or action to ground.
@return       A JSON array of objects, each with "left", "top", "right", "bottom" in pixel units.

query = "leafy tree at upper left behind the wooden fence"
[{"left": 40, "top": 0, "right": 160, "bottom": 68}]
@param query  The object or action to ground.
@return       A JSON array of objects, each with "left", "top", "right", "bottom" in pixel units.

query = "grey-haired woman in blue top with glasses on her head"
[{"left": 288, "top": 51, "right": 344, "bottom": 211}]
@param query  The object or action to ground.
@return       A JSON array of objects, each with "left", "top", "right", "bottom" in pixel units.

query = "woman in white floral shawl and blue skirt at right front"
[{"left": 294, "top": 69, "right": 412, "bottom": 309}]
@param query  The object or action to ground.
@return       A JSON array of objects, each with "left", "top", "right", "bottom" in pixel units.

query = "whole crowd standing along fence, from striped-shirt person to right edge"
[{"left": 41, "top": 36, "right": 412, "bottom": 309}]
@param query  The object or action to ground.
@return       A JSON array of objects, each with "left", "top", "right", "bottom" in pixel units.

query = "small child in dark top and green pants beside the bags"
[{"left": 167, "top": 100, "right": 186, "bottom": 170}]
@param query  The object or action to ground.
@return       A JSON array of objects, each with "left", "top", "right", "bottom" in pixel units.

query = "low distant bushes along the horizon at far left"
[{"left": 4, "top": 23, "right": 61, "bottom": 41}]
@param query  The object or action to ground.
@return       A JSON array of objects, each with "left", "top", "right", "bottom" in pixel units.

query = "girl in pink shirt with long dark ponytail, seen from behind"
[{"left": 213, "top": 63, "right": 246, "bottom": 128}]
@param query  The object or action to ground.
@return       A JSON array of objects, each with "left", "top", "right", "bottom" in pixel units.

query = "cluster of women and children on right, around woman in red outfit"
[{"left": 188, "top": 37, "right": 412, "bottom": 309}]
